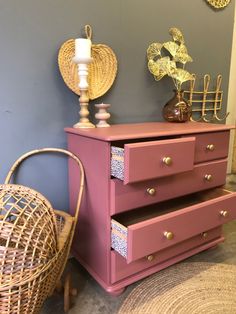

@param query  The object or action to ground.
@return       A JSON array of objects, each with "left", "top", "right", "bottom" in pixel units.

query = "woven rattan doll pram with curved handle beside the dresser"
[{"left": 0, "top": 148, "right": 84, "bottom": 314}]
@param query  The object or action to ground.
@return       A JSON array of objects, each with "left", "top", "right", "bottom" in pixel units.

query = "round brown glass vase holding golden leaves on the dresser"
[{"left": 162, "top": 90, "right": 191, "bottom": 122}]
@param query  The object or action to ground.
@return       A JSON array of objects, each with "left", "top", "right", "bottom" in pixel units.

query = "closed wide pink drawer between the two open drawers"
[{"left": 110, "top": 159, "right": 227, "bottom": 215}]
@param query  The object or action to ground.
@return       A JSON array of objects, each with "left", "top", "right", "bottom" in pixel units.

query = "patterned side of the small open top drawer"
[{"left": 111, "top": 146, "right": 124, "bottom": 180}]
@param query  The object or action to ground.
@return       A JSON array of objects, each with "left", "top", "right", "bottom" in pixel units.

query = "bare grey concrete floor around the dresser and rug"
[{"left": 41, "top": 175, "right": 236, "bottom": 314}]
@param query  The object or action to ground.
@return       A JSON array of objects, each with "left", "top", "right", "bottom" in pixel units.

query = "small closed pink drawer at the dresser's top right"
[{"left": 184, "top": 130, "right": 230, "bottom": 163}]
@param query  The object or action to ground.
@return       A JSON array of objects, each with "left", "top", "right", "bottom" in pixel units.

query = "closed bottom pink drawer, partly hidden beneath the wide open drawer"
[{"left": 111, "top": 227, "right": 222, "bottom": 283}]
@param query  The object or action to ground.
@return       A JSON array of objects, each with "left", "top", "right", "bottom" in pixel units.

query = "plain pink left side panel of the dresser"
[{"left": 68, "top": 134, "right": 110, "bottom": 282}]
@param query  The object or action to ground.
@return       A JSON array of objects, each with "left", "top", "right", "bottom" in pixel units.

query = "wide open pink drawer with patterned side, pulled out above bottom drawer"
[{"left": 111, "top": 188, "right": 236, "bottom": 263}]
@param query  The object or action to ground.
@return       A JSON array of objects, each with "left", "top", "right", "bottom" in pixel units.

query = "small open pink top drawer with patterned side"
[{"left": 111, "top": 137, "right": 195, "bottom": 184}]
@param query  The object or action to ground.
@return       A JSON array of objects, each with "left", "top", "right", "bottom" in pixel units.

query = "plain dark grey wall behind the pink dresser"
[{"left": 0, "top": 0, "right": 235, "bottom": 208}]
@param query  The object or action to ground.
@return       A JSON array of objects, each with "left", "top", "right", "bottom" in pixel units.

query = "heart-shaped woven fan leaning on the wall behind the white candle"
[{"left": 58, "top": 39, "right": 117, "bottom": 99}]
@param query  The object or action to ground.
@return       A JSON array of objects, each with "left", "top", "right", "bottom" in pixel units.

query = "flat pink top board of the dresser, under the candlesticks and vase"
[{"left": 65, "top": 122, "right": 235, "bottom": 141}]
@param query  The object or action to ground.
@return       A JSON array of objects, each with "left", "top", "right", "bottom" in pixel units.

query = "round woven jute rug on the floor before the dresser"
[{"left": 118, "top": 262, "right": 236, "bottom": 314}]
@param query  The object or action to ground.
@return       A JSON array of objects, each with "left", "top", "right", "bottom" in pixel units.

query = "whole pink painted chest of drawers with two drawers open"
[{"left": 66, "top": 122, "right": 236, "bottom": 295}]
